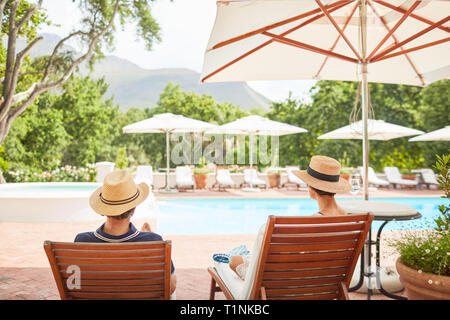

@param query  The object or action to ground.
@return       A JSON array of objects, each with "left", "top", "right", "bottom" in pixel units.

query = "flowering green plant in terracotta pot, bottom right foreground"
[{"left": 390, "top": 155, "right": 450, "bottom": 300}]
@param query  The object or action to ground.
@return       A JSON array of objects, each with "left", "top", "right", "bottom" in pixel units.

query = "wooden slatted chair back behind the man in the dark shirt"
[{"left": 44, "top": 241, "right": 172, "bottom": 300}]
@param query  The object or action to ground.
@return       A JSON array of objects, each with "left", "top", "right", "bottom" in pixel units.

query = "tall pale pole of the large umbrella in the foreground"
[{"left": 360, "top": 0, "right": 369, "bottom": 200}]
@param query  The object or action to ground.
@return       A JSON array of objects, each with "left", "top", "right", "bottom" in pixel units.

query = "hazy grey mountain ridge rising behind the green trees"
[{"left": 22, "top": 34, "right": 271, "bottom": 110}]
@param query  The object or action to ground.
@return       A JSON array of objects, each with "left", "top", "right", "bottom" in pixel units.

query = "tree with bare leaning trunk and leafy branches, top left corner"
[{"left": 0, "top": 0, "right": 160, "bottom": 145}]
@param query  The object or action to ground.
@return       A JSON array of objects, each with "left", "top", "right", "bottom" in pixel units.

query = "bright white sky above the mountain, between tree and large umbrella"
[{"left": 42, "top": 0, "right": 314, "bottom": 101}]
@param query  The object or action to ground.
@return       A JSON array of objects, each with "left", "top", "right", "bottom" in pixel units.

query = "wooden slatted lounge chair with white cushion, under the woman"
[{"left": 208, "top": 213, "right": 373, "bottom": 300}]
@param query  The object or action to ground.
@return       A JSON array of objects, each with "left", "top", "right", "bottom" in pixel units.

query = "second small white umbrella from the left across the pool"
[{"left": 205, "top": 115, "right": 308, "bottom": 191}]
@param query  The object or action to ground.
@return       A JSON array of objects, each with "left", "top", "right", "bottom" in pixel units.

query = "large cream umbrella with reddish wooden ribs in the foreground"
[{"left": 201, "top": 0, "right": 450, "bottom": 200}]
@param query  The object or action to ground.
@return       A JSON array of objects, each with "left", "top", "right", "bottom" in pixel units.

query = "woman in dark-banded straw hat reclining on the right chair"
[{"left": 229, "top": 156, "right": 351, "bottom": 279}]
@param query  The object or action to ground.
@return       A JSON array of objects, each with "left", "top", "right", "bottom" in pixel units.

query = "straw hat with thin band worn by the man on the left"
[{"left": 89, "top": 170, "right": 149, "bottom": 216}]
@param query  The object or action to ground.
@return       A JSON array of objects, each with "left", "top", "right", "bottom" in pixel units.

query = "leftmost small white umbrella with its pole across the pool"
[{"left": 122, "top": 113, "right": 216, "bottom": 192}]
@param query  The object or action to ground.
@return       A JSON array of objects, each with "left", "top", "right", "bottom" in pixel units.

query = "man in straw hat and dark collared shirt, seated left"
[{"left": 75, "top": 170, "right": 176, "bottom": 294}]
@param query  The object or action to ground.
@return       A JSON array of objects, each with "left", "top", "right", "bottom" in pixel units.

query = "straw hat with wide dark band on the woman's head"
[{"left": 292, "top": 156, "right": 351, "bottom": 193}]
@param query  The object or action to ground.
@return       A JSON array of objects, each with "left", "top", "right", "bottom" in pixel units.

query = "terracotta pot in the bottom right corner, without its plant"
[{"left": 396, "top": 258, "right": 450, "bottom": 300}]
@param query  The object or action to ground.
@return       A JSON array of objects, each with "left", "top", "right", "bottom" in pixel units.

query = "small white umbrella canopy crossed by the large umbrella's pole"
[{"left": 318, "top": 119, "right": 424, "bottom": 140}]
